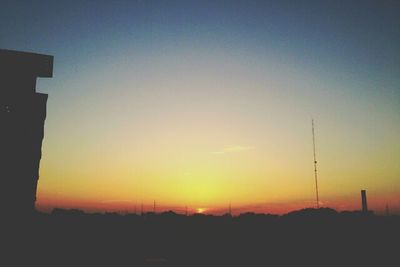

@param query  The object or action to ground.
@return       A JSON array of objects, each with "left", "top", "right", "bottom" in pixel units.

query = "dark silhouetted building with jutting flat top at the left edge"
[{"left": 0, "top": 49, "right": 53, "bottom": 217}]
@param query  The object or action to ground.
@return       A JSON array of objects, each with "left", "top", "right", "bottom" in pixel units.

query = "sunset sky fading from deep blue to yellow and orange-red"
[{"left": 0, "top": 0, "right": 400, "bottom": 214}]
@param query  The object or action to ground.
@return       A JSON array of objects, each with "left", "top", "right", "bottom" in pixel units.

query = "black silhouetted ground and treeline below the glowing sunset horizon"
[{"left": 0, "top": 209, "right": 400, "bottom": 266}]
